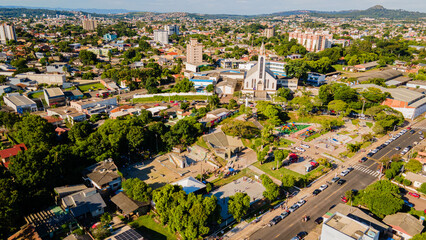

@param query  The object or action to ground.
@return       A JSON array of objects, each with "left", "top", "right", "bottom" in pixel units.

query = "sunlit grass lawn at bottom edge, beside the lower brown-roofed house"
[{"left": 130, "top": 214, "right": 177, "bottom": 240}]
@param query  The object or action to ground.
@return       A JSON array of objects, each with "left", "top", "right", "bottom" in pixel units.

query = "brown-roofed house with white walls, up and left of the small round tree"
[{"left": 83, "top": 159, "right": 121, "bottom": 193}]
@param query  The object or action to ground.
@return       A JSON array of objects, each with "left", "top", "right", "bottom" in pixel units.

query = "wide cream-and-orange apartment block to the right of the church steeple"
[{"left": 289, "top": 31, "right": 333, "bottom": 52}]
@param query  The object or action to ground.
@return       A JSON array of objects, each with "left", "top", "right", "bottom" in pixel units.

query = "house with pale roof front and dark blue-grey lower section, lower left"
[{"left": 61, "top": 187, "right": 106, "bottom": 218}]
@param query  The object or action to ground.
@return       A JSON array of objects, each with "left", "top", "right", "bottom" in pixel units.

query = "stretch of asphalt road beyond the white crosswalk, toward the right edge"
[{"left": 371, "top": 129, "right": 421, "bottom": 160}]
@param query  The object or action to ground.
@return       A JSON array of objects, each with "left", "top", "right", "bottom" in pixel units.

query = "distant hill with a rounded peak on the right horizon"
[{"left": 309, "top": 5, "right": 426, "bottom": 19}]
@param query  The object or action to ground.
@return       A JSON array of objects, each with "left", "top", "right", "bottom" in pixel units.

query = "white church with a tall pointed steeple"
[{"left": 241, "top": 44, "right": 278, "bottom": 99}]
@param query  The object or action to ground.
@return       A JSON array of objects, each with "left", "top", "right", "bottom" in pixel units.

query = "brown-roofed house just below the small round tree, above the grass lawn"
[{"left": 111, "top": 192, "right": 151, "bottom": 216}]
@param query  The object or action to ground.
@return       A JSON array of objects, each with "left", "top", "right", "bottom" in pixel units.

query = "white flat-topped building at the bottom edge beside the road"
[{"left": 321, "top": 212, "right": 380, "bottom": 240}]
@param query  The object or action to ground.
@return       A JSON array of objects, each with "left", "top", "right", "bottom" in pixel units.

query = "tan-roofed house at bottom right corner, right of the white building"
[{"left": 383, "top": 212, "right": 424, "bottom": 239}]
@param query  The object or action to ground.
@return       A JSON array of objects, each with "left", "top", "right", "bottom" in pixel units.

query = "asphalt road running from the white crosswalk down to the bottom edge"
[{"left": 250, "top": 160, "right": 378, "bottom": 240}]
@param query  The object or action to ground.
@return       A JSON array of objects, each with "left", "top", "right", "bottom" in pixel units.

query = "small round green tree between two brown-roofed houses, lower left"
[{"left": 122, "top": 178, "right": 152, "bottom": 202}]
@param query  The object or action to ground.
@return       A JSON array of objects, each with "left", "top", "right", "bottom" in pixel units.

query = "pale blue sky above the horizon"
[{"left": 0, "top": 0, "right": 426, "bottom": 15}]
